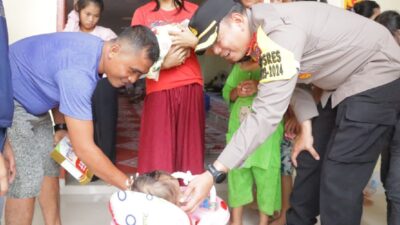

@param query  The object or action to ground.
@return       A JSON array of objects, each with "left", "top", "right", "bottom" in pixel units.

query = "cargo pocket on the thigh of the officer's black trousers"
[{"left": 328, "top": 102, "right": 397, "bottom": 163}]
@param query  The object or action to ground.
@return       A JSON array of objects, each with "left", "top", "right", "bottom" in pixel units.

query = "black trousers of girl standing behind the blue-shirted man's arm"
[{"left": 92, "top": 79, "right": 118, "bottom": 164}]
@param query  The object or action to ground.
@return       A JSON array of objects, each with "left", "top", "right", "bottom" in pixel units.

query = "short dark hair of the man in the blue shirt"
[{"left": 117, "top": 25, "right": 160, "bottom": 63}]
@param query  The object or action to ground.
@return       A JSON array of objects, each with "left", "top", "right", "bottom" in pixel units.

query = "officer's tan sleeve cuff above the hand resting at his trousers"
[{"left": 290, "top": 86, "right": 318, "bottom": 123}]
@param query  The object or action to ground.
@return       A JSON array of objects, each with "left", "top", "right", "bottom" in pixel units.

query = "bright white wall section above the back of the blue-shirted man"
[{"left": 3, "top": 0, "right": 57, "bottom": 44}]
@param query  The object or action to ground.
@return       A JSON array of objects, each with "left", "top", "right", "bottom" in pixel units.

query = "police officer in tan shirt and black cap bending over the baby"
[{"left": 183, "top": 0, "right": 400, "bottom": 225}]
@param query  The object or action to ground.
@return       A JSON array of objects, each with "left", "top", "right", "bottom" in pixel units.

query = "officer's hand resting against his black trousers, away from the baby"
[{"left": 291, "top": 120, "right": 320, "bottom": 167}]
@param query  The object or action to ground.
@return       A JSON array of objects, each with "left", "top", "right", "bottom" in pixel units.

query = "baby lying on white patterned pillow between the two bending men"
[{"left": 109, "top": 170, "right": 229, "bottom": 225}]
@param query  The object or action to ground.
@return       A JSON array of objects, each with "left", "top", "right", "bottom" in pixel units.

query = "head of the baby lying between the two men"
[{"left": 131, "top": 170, "right": 180, "bottom": 205}]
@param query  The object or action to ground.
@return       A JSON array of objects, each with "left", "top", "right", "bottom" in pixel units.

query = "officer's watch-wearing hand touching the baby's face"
[{"left": 181, "top": 171, "right": 214, "bottom": 213}]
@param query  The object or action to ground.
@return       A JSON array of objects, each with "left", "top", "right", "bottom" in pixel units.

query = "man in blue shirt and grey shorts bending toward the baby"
[{"left": 5, "top": 26, "right": 159, "bottom": 225}]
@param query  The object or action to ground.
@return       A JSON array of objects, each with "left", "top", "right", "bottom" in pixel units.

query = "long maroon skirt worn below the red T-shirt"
[{"left": 138, "top": 84, "right": 205, "bottom": 174}]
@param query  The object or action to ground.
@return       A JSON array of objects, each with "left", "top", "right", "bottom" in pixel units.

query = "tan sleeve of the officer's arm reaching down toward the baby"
[{"left": 218, "top": 76, "right": 297, "bottom": 168}]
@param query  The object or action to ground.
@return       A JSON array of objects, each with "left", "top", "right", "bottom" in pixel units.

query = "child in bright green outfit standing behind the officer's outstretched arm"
[{"left": 222, "top": 64, "right": 284, "bottom": 225}]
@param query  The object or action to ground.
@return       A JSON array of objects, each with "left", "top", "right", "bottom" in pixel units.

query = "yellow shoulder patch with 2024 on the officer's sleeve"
[{"left": 257, "top": 27, "right": 300, "bottom": 83}]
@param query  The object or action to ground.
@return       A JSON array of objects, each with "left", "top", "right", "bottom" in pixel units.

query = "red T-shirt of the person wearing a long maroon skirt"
[{"left": 131, "top": 1, "right": 203, "bottom": 94}]
